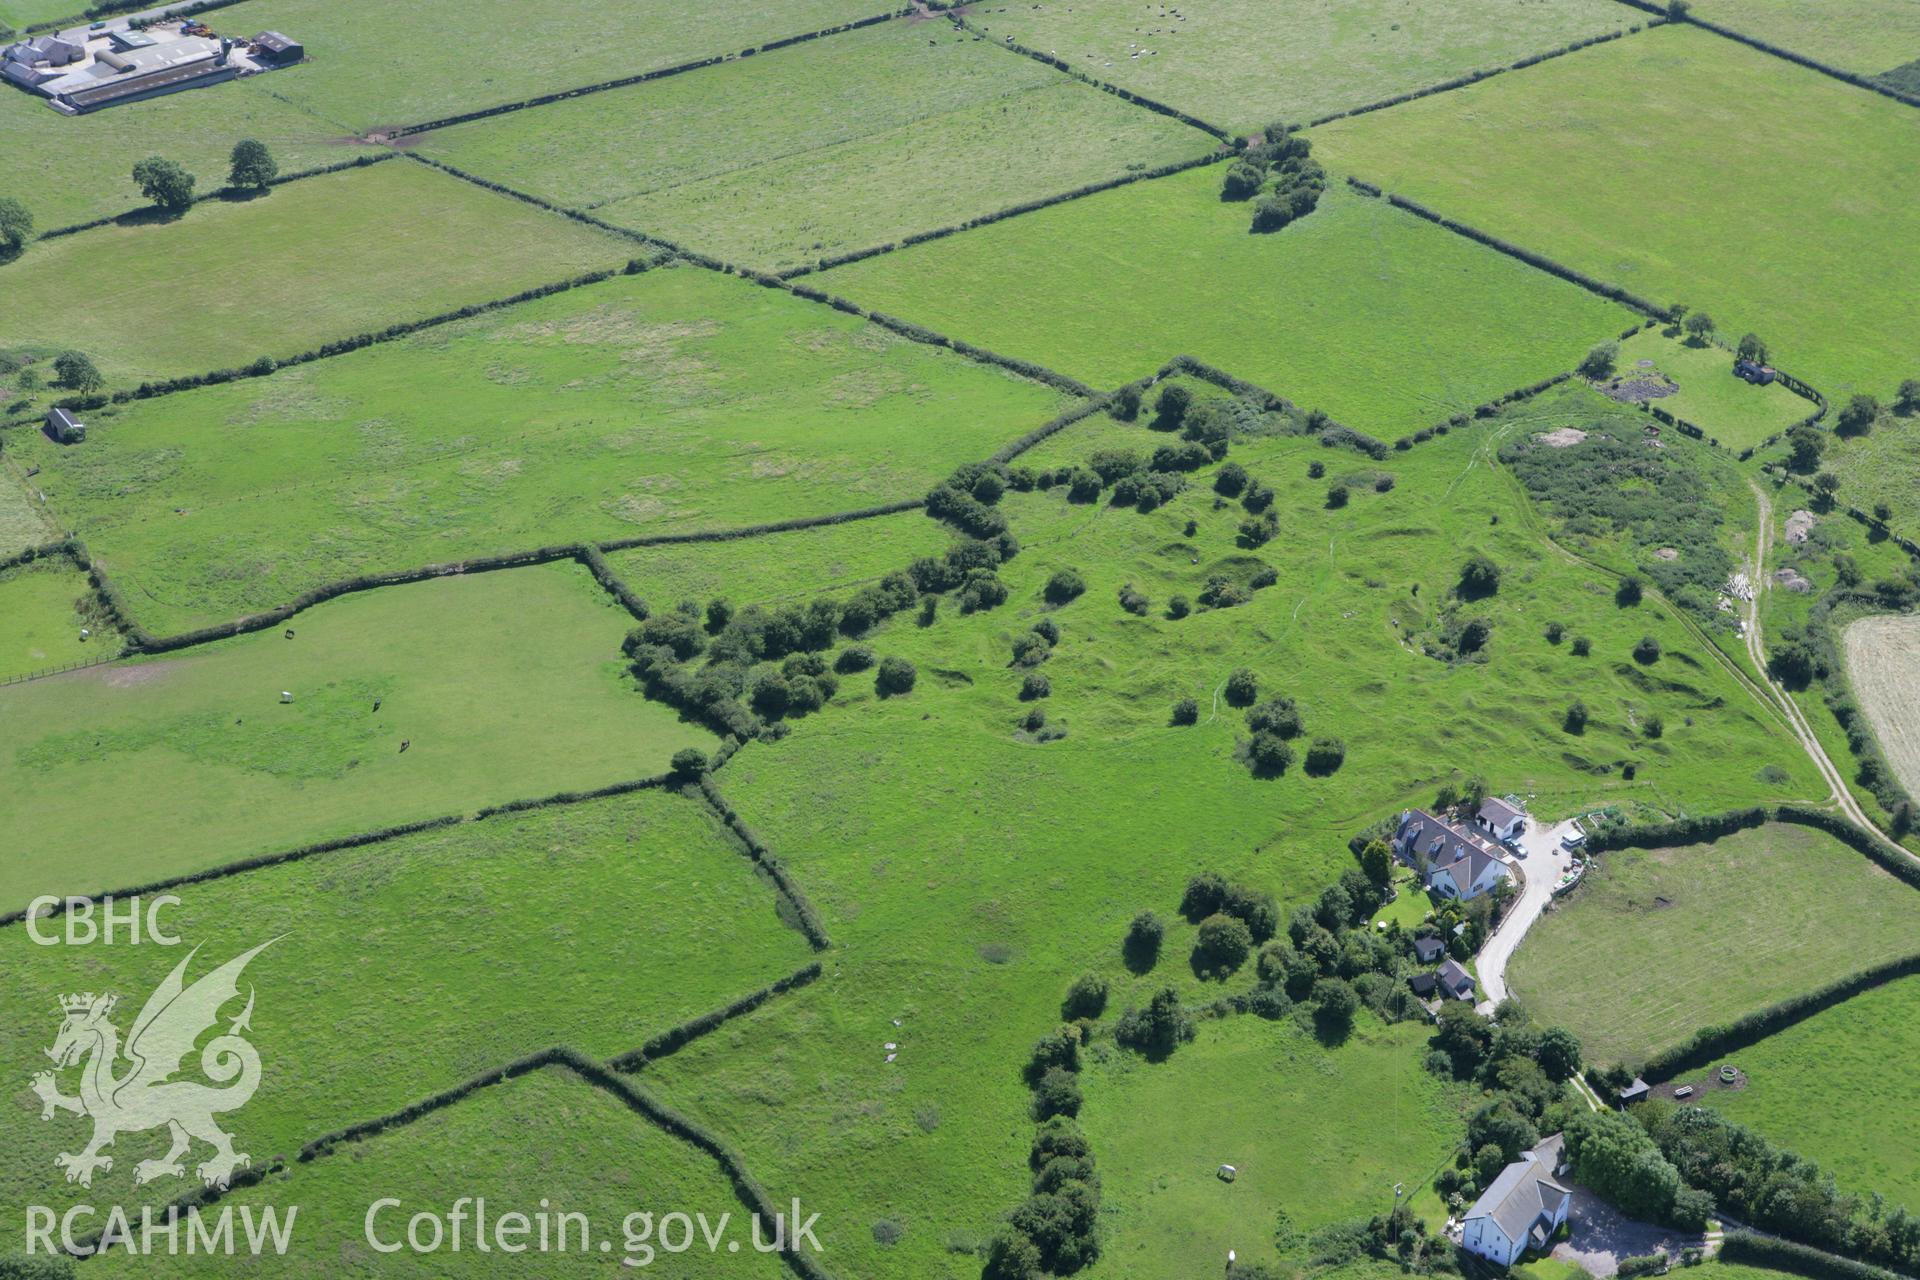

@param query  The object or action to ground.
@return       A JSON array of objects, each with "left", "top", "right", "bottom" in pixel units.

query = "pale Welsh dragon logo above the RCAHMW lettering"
[{"left": 33, "top": 938, "right": 278, "bottom": 1188}]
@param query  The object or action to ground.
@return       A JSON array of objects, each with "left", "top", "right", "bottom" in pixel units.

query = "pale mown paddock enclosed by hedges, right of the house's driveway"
[{"left": 1507, "top": 825, "right": 1920, "bottom": 1063}]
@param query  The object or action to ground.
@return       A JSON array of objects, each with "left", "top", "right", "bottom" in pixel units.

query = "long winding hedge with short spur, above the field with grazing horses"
[{"left": 75, "top": 497, "right": 925, "bottom": 658}]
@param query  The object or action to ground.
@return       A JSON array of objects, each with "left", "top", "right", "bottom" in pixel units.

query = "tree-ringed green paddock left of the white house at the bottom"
[{"left": 1079, "top": 1013, "right": 1461, "bottom": 1280}]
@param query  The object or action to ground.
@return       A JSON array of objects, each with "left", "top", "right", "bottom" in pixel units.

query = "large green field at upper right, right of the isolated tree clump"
[{"left": 1313, "top": 27, "right": 1920, "bottom": 403}]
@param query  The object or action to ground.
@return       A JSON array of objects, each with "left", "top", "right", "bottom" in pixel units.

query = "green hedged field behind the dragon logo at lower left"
[{"left": 0, "top": 791, "right": 810, "bottom": 1251}]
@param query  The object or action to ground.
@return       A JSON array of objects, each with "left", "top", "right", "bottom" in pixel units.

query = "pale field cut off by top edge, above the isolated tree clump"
[{"left": 970, "top": 0, "right": 1640, "bottom": 132}]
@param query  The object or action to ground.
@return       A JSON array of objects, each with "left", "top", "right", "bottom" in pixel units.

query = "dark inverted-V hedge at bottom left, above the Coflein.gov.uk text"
[{"left": 79, "top": 1046, "right": 833, "bottom": 1280}]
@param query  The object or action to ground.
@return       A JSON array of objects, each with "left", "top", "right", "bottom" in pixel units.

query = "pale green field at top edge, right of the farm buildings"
[{"left": 189, "top": 0, "right": 889, "bottom": 132}]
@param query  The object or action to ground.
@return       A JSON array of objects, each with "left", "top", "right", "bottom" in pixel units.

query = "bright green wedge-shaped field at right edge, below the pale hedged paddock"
[{"left": 1690, "top": 977, "right": 1920, "bottom": 1209}]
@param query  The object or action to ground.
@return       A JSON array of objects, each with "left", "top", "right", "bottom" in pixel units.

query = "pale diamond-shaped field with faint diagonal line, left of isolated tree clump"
[{"left": 409, "top": 21, "right": 1213, "bottom": 271}]
